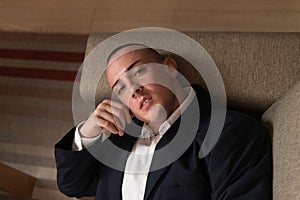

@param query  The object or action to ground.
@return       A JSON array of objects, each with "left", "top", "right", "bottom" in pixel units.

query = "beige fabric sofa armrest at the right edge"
[{"left": 262, "top": 82, "right": 300, "bottom": 200}]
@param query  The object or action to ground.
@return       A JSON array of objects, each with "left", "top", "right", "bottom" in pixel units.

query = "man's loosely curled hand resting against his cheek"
[{"left": 79, "top": 99, "right": 131, "bottom": 138}]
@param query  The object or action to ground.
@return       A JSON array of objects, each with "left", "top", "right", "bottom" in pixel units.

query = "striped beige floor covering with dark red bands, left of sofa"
[{"left": 0, "top": 32, "right": 87, "bottom": 200}]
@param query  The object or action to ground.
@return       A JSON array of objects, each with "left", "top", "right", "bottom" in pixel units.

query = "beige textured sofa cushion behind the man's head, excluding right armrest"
[{"left": 82, "top": 32, "right": 300, "bottom": 113}]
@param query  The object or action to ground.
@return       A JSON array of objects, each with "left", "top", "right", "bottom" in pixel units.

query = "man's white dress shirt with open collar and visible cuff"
[{"left": 73, "top": 87, "right": 196, "bottom": 200}]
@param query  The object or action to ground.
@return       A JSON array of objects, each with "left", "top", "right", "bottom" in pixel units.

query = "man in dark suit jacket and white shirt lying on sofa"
[{"left": 55, "top": 44, "right": 272, "bottom": 200}]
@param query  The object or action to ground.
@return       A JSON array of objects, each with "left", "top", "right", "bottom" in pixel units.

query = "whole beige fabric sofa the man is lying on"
[{"left": 81, "top": 32, "right": 300, "bottom": 200}]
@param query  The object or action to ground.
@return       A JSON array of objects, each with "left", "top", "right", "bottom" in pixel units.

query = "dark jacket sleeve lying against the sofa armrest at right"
[{"left": 206, "top": 117, "right": 272, "bottom": 200}]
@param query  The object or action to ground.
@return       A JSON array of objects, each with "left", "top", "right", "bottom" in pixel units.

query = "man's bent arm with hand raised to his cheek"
[{"left": 55, "top": 100, "right": 131, "bottom": 197}]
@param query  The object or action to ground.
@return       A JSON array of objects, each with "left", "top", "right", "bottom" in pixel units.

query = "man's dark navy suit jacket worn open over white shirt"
[{"left": 55, "top": 86, "right": 272, "bottom": 200}]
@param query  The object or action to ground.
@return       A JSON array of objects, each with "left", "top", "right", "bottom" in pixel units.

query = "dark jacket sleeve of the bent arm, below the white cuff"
[{"left": 55, "top": 128, "right": 100, "bottom": 198}]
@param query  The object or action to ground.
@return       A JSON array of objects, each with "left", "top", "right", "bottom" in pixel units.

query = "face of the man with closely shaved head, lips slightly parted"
[{"left": 106, "top": 50, "right": 179, "bottom": 123}]
